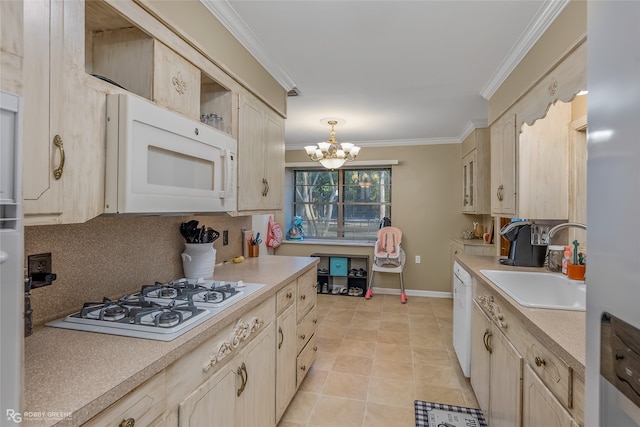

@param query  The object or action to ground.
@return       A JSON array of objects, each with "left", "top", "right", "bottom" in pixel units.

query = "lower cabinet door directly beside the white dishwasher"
[{"left": 471, "top": 302, "right": 491, "bottom": 415}]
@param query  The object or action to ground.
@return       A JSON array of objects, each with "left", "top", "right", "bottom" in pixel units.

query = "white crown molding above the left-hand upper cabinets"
[{"left": 200, "top": 0, "right": 296, "bottom": 92}]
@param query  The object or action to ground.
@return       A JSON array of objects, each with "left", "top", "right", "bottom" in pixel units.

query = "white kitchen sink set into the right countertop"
[{"left": 480, "top": 270, "right": 586, "bottom": 311}]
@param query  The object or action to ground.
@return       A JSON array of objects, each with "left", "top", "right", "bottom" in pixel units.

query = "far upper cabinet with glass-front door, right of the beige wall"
[{"left": 461, "top": 128, "right": 491, "bottom": 214}]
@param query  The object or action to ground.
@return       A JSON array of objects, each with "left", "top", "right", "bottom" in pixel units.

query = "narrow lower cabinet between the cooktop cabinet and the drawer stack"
[{"left": 276, "top": 280, "right": 298, "bottom": 423}]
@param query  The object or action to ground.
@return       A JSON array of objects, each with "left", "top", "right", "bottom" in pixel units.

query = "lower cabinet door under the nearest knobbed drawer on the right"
[{"left": 522, "top": 365, "right": 575, "bottom": 427}]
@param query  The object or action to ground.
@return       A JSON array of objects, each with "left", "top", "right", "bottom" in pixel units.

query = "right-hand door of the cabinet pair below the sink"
[{"left": 489, "top": 325, "right": 524, "bottom": 427}]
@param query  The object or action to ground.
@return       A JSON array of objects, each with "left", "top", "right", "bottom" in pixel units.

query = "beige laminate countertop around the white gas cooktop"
[{"left": 23, "top": 256, "right": 318, "bottom": 426}]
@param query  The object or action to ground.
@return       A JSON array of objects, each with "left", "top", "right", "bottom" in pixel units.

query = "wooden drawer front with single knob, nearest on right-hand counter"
[{"left": 524, "top": 334, "right": 573, "bottom": 408}]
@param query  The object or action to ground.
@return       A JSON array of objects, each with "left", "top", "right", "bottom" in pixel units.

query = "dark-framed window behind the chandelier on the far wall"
[{"left": 293, "top": 168, "right": 391, "bottom": 240}]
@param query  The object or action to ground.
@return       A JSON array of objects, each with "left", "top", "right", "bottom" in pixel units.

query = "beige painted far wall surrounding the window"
[{"left": 276, "top": 144, "right": 478, "bottom": 292}]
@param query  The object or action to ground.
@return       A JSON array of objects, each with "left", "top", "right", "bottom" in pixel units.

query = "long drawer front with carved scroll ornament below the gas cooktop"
[{"left": 167, "top": 296, "right": 276, "bottom": 408}]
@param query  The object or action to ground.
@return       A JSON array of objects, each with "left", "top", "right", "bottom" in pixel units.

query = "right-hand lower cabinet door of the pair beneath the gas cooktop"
[{"left": 236, "top": 322, "right": 276, "bottom": 427}]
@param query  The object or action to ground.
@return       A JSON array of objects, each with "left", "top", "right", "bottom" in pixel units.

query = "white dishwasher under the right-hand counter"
[{"left": 453, "top": 261, "right": 473, "bottom": 377}]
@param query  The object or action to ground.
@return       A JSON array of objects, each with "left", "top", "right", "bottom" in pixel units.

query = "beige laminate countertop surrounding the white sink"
[{"left": 457, "top": 255, "right": 586, "bottom": 379}]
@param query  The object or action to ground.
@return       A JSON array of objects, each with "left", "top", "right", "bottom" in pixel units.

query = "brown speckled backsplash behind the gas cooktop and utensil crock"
[{"left": 24, "top": 216, "right": 251, "bottom": 325}]
